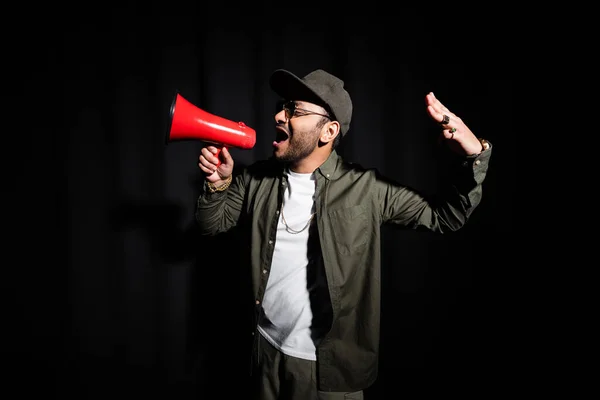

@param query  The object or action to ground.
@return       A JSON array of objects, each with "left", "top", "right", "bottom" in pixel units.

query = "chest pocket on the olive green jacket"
[{"left": 329, "top": 205, "right": 370, "bottom": 255}]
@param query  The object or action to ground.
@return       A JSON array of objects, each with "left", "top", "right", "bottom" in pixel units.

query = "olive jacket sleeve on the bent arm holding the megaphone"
[{"left": 195, "top": 175, "right": 245, "bottom": 236}]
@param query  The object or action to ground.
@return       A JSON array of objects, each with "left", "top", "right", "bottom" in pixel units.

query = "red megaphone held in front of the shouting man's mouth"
[{"left": 165, "top": 91, "right": 256, "bottom": 164}]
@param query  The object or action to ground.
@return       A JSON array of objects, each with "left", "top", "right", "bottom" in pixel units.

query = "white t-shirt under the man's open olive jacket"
[{"left": 258, "top": 171, "right": 316, "bottom": 361}]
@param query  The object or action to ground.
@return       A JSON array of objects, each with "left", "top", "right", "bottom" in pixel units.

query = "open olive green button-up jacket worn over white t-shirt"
[{"left": 196, "top": 147, "right": 492, "bottom": 391}]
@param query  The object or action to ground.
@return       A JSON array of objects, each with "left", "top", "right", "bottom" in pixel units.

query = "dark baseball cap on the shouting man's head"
[{"left": 269, "top": 69, "right": 352, "bottom": 136}]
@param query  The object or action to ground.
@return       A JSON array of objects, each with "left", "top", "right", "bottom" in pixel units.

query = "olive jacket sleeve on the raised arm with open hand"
[{"left": 379, "top": 143, "right": 492, "bottom": 233}]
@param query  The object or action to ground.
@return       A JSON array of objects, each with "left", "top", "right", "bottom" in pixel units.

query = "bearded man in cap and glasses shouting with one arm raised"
[{"left": 196, "top": 69, "right": 491, "bottom": 400}]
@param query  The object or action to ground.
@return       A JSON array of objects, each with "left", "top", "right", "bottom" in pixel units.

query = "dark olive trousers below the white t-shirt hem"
[{"left": 252, "top": 332, "right": 364, "bottom": 400}]
